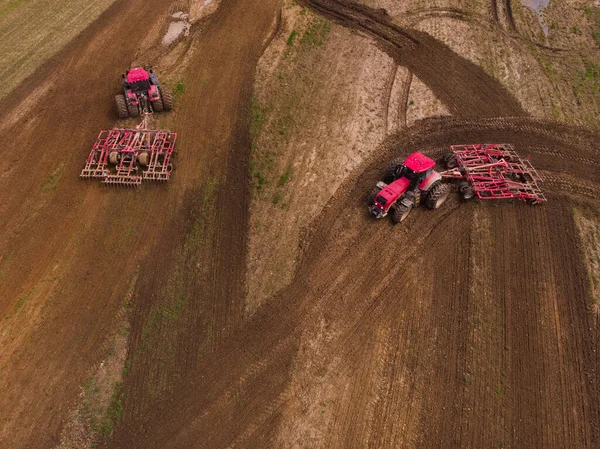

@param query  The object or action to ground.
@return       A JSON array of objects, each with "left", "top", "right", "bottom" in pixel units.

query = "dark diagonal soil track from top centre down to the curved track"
[{"left": 300, "top": 0, "right": 527, "bottom": 117}]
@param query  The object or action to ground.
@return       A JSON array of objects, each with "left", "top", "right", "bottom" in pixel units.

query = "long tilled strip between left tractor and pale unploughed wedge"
[{"left": 105, "top": 0, "right": 280, "bottom": 440}]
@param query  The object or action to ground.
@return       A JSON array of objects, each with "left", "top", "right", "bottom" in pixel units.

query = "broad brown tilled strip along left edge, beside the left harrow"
[{"left": 0, "top": 0, "right": 179, "bottom": 448}]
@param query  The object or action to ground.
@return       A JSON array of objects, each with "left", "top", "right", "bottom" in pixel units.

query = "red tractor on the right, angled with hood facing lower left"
[{"left": 369, "top": 152, "right": 450, "bottom": 223}]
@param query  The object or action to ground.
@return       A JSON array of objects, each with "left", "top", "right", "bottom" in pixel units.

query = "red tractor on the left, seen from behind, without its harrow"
[{"left": 115, "top": 67, "right": 173, "bottom": 119}]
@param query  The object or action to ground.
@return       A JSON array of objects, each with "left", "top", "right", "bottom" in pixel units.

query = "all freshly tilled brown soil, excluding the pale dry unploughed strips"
[{"left": 0, "top": 0, "right": 600, "bottom": 449}]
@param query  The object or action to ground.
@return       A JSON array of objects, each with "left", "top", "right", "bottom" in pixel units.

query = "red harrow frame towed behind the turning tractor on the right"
[{"left": 440, "top": 144, "right": 546, "bottom": 204}]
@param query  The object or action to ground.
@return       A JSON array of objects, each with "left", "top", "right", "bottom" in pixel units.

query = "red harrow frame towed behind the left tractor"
[{"left": 79, "top": 117, "right": 177, "bottom": 186}]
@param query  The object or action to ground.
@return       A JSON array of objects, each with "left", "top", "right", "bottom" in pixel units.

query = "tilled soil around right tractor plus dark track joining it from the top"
[{"left": 114, "top": 1, "right": 600, "bottom": 448}]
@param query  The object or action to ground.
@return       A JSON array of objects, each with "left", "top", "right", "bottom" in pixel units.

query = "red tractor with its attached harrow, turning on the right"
[{"left": 369, "top": 144, "right": 546, "bottom": 223}]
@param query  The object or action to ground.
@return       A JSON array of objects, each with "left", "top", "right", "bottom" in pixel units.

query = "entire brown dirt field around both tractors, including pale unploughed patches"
[{"left": 0, "top": 0, "right": 600, "bottom": 449}]
